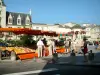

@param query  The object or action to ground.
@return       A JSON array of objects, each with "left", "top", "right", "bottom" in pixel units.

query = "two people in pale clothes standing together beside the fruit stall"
[{"left": 37, "top": 38, "right": 56, "bottom": 57}]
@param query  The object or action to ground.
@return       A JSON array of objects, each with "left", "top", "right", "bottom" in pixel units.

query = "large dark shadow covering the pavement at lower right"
[{"left": 39, "top": 52, "right": 100, "bottom": 75}]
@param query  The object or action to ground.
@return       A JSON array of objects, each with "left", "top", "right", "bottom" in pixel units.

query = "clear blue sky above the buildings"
[{"left": 4, "top": 0, "right": 100, "bottom": 25}]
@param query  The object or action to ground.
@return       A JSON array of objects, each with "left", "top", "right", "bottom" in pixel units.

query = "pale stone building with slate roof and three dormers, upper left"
[{"left": 0, "top": 0, "right": 32, "bottom": 28}]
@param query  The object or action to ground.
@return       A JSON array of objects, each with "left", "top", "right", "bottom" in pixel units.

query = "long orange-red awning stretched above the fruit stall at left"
[{"left": 0, "top": 28, "right": 57, "bottom": 36}]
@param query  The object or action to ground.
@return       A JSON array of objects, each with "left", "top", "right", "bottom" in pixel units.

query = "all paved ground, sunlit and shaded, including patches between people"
[{"left": 0, "top": 44, "right": 100, "bottom": 75}]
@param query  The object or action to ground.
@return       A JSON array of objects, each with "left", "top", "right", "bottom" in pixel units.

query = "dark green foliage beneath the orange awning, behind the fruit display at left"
[{"left": 0, "top": 35, "right": 37, "bottom": 46}]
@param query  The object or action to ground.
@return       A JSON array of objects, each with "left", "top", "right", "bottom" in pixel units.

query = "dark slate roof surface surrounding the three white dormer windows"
[{"left": 6, "top": 11, "right": 32, "bottom": 25}]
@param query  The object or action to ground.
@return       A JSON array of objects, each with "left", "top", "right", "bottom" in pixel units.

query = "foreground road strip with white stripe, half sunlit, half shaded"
[{"left": 0, "top": 60, "right": 100, "bottom": 75}]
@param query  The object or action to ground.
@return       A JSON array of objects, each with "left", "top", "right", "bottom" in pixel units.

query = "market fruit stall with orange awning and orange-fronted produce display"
[{"left": 0, "top": 28, "right": 57, "bottom": 60}]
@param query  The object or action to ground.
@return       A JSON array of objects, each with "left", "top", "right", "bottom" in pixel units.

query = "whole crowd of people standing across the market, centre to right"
[{"left": 37, "top": 38, "right": 98, "bottom": 61}]
